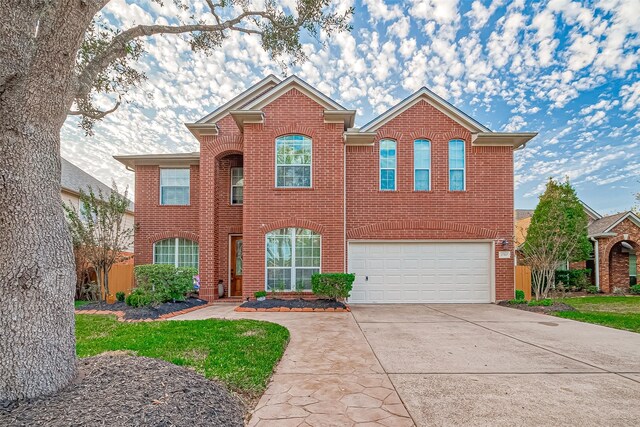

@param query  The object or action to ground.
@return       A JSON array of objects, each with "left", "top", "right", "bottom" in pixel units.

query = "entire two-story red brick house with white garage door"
[{"left": 116, "top": 76, "right": 535, "bottom": 303}]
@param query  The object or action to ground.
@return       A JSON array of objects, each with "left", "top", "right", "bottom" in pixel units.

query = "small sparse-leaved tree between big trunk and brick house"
[{"left": 64, "top": 186, "right": 134, "bottom": 301}]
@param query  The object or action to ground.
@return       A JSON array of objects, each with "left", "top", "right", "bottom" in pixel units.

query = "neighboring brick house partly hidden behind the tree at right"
[{"left": 515, "top": 203, "right": 640, "bottom": 293}]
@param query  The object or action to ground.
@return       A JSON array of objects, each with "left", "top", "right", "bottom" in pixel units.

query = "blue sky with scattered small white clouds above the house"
[{"left": 57, "top": 0, "right": 640, "bottom": 213}]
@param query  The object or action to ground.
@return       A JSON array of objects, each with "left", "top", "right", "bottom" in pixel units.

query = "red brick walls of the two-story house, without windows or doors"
[{"left": 129, "top": 83, "right": 514, "bottom": 300}]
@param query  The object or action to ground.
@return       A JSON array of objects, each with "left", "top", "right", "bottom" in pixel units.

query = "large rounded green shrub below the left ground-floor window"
[{"left": 134, "top": 264, "right": 198, "bottom": 304}]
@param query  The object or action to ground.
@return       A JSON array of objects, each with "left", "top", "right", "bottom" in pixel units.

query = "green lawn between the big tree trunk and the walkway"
[{"left": 76, "top": 314, "right": 289, "bottom": 397}]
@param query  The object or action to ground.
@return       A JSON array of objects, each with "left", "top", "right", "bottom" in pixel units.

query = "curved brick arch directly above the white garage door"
[{"left": 347, "top": 220, "right": 498, "bottom": 239}]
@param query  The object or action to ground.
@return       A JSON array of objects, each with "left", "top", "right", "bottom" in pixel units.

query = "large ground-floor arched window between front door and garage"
[{"left": 265, "top": 228, "right": 320, "bottom": 291}]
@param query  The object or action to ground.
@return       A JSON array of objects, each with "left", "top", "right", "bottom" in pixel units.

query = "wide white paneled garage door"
[{"left": 348, "top": 241, "right": 492, "bottom": 303}]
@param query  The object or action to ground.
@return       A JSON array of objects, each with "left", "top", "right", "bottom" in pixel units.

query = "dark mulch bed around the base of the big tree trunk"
[{"left": 0, "top": 352, "right": 244, "bottom": 427}]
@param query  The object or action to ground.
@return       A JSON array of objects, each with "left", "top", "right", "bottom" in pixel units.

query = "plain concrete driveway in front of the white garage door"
[{"left": 352, "top": 304, "right": 640, "bottom": 426}]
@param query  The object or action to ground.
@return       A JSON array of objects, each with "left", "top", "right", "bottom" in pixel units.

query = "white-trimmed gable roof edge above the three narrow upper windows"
[{"left": 360, "top": 86, "right": 491, "bottom": 133}]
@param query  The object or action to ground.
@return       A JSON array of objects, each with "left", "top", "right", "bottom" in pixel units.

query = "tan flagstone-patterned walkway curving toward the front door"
[{"left": 172, "top": 305, "right": 414, "bottom": 427}]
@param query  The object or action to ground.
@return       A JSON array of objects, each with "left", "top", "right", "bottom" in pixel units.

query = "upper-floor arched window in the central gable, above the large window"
[{"left": 276, "top": 135, "right": 311, "bottom": 188}]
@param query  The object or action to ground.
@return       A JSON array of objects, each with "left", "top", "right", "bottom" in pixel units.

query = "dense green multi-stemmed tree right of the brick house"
[{"left": 522, "top": 179, "right": 592, "bottom": 300}]
